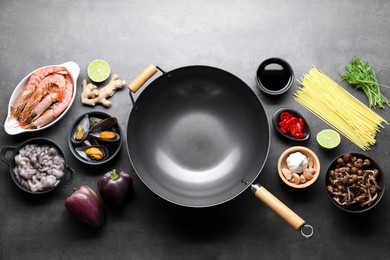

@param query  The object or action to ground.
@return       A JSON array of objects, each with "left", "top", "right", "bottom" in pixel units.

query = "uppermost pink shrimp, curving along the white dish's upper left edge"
[{"left": 11, "top": 66, "right": 68, "bottom": 118}]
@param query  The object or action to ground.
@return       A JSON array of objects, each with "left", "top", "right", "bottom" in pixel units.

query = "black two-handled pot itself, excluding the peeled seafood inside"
[{"left": 0, "top": 138, "right": 74, "bottom": 194}]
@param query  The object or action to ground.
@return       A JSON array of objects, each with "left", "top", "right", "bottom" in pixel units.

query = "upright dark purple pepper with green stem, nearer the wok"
[{"left": 97, "top": 169, "right": 133, "bottom": 207}]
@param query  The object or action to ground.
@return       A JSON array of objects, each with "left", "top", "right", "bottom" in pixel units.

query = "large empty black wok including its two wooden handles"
[{"left": 127, "top": 65, "right": 312, "bottom": 238}]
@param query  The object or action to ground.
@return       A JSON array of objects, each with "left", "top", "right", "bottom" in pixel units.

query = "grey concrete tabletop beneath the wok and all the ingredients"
[{"left": 0, "top": 0, "right": 390, "bottom": 259}]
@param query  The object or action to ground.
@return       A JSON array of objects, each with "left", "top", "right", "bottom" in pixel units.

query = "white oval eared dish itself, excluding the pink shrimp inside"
[{"left": 4, "top": 61, "right": 80, "bottom": 135}]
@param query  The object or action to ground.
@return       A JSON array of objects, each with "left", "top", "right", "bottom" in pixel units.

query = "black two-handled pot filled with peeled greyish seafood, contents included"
[{"left": 0, "top": 138, "right": 74, "bottom": 194}]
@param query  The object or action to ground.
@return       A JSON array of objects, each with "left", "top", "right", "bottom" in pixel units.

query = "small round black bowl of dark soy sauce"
[{"left": 256, "top": 58, "right": 294, "bottom": 96}]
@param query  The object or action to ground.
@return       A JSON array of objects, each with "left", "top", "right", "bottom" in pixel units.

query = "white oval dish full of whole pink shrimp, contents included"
[{"left": 4, "top": 61, "right": 80, "bottom": 135}]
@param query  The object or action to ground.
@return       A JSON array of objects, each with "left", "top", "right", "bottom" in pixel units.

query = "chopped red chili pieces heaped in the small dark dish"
[{"left": 278, "top": 112, "right": 305, "bottom": 139}]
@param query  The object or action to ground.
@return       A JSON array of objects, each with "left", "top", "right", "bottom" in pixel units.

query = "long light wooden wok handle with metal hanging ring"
[{"left": 252, "top": 184, "right": 313, "bottom": 238}]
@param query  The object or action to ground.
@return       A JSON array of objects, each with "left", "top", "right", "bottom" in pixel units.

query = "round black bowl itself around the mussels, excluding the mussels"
[{"left": 68, "top": 111, "right": 123, "bottom": 165}]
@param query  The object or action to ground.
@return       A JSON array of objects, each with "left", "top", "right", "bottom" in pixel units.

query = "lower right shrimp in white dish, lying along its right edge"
[{"left": 25, "top": 75, "right": 73, "bottom": 129}]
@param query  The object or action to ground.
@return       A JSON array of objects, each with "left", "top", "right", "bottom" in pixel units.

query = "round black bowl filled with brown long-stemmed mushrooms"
[{"left": 325, "top": 153, "right": 385, "bottom": 213}]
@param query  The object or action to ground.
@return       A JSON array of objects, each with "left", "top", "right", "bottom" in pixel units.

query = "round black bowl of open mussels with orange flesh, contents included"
[{"left": 68, "top": 111, "right": 123, "bottom": 165}]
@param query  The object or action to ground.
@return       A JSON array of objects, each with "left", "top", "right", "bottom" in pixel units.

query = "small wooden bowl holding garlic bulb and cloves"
[{"left": 278, "top": 146, "right": 320, "bottom": 189}]
